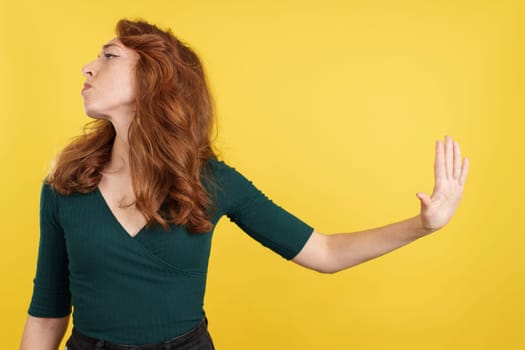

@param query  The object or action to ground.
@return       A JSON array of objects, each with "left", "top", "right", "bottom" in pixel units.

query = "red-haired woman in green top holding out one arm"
[{"left": 21, "top": 20, "right": 468, "bottom": 350}]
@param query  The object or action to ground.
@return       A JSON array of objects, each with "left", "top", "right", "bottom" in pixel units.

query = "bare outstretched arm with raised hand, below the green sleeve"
[{"left": 293, "top": 136, "right": 469, "bottom": 273}]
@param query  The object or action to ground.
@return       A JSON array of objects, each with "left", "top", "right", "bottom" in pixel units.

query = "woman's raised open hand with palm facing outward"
[{"left": 416, "top": 136, "right": 469, "bottom": 234}]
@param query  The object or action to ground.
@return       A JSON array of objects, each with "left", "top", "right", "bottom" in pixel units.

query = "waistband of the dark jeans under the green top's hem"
[{"left": 71, "top": 318, "right": 208, "bottom": 350}]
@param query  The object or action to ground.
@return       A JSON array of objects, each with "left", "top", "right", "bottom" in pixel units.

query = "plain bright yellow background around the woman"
[{"left": 0, "top": 0, "right": 525, "bottom": 349}]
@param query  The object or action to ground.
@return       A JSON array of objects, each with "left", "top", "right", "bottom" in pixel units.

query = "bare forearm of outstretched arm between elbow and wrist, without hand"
[{"left": 325, "top": 216, "right": 430, "bottom": 272}]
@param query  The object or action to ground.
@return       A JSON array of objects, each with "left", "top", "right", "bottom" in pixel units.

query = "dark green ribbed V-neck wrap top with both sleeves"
[{"left": 29, "top": 160, "right": 313, "bottom": 345}]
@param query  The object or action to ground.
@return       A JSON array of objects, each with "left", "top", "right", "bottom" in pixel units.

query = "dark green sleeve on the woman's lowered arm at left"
[{"left": 28, "top": 184, "right": 71, "bottom": 317}]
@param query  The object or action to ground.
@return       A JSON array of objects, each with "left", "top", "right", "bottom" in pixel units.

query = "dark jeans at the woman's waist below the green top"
[{"left": 66, "top": 318, "right": 215, "bottom": 350}]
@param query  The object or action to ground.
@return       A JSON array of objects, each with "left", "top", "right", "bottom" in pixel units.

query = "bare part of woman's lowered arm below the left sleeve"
[{"left": 20, "top": 315, "right": 69, "bottom": 350}]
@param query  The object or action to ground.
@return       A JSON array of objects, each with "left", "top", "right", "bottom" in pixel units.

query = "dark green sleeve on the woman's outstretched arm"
[{"left": 209, "top": 161, "right": 313, "bottom": 260}]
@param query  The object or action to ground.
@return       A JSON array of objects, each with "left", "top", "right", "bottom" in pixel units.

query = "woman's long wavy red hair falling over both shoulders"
[{"left": 46, "top": 19, "right": 216, "bottom": 233}]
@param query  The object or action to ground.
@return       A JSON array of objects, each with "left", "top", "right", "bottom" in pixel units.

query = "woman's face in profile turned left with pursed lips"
[{"left": 82, "top": 38, "right": 139, "bottom": 121}]
